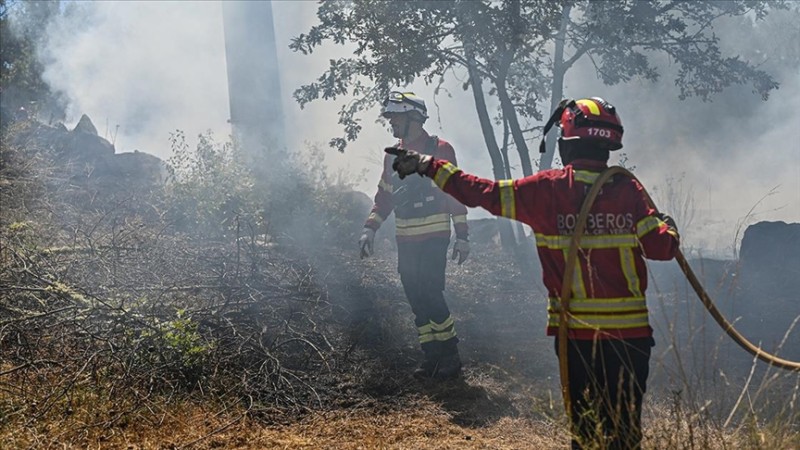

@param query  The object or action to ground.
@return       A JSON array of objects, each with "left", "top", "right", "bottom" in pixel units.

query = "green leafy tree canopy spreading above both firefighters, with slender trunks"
[{"left": 290, "top": 0, "right": 786, "bottom": 173}]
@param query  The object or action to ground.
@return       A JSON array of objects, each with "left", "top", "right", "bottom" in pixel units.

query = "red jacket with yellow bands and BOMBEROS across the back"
[{"left": 426, "top": 159, "right": 678, "bottom": 339}]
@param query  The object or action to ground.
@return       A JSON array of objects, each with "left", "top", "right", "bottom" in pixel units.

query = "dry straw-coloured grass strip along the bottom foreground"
[{"left": 0, "top": 388, "right": 567, "bottom": 450}]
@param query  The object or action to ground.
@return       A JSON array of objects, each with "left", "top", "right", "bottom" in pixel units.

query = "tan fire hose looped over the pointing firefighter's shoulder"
[{"left": 558, "top": 166, "right": 800, "bottom": 417}]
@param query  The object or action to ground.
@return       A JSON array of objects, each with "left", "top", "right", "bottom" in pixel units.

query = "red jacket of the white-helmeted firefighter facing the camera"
[{"left": 364, "top": 132, "right": 468, "bottom": 243}]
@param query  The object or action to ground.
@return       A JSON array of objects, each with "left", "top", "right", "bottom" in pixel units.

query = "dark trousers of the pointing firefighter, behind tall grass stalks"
[{"left": 555, "top": 338, "right": 655, "bottom": 450}]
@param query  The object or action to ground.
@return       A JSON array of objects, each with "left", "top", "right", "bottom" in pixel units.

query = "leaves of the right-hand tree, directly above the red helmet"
[{"left": 540, "top": 0, "right": 786, "bottom": 168}]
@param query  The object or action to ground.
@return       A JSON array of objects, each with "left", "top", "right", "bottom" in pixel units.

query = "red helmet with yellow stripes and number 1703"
[{"left": 540, "top": 97, "right": 623, "bottom": 153}]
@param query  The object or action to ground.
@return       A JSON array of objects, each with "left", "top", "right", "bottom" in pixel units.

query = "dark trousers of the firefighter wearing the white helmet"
[{"left": 397, "top": 238, "right": 458, "bottom": 359}]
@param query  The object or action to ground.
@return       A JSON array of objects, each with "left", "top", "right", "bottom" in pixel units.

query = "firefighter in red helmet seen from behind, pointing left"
[{"left": 387, "top": 97, "right": 679, "bottom": 449}]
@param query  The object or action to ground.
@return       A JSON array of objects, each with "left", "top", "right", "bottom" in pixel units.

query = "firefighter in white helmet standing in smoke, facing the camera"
[{"left": 359, "top": 92, "right": 469, "bottom": 380}]
